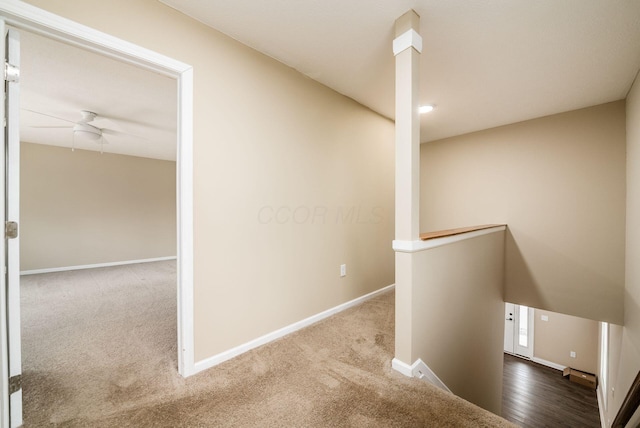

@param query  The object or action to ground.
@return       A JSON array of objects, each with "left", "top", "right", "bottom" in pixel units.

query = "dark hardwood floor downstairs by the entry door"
[{"left": 502, "top": 354, "right": 601, "bottom": 428}]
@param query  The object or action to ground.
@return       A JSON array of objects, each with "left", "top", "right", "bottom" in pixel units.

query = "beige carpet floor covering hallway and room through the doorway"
[{"left": 21, "top": 262, "right": 513, "bottom": 427}]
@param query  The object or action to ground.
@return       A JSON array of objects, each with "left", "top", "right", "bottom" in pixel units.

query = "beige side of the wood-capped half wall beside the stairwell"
[{"left": 411, "top": 232, "right": 505, "bottom": 415}]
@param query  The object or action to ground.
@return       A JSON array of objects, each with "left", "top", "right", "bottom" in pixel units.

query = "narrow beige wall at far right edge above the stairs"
[{"left": 607, "top": 70, "right": 640, "bottom": 426}]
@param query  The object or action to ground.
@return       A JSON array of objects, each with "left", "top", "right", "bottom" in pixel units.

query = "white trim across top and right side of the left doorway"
[{"left": 0, "top": 0, "right": 195, "bottom": 392}]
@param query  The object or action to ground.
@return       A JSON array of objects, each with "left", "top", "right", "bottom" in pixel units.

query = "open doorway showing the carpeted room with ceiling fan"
[{"left": 20, "top": 26, "right": 178, "bottom": 425}]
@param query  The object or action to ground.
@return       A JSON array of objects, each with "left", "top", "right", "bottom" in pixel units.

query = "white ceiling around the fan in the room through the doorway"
[{"left": 20, "top": 31, "right": 177, "bottom": 160}]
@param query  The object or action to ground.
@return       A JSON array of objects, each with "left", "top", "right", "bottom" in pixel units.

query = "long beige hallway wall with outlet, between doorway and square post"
[{"left": 22, "top": 0, "right": 394, "bottom": 361}]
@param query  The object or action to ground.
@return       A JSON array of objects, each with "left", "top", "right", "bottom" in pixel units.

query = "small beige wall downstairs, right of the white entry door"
[{"left": 533, "top": 309, "right": 599, "bottom": 373}]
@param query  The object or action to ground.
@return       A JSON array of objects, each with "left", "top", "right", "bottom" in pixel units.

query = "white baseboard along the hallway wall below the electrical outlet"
[{"left": 193, "top": 284, "right": 395, "bottom": 374}]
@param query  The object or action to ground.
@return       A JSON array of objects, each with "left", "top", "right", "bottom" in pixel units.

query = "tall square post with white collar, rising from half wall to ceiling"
[{"left": 393, "top": 10, "right": 422, "bottom": 374}]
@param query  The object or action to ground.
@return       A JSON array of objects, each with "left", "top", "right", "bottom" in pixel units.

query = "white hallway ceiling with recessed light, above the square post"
[{"left": 160, "top": 0, "right": 640, "bottom": 142}]
